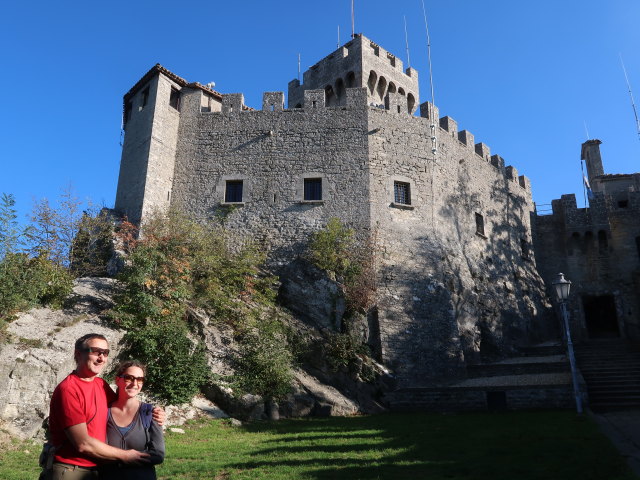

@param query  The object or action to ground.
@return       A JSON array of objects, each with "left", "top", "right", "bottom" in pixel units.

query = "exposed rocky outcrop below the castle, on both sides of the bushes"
[{"left": 0, "top": 278, "right": 388, "bottom": 438}]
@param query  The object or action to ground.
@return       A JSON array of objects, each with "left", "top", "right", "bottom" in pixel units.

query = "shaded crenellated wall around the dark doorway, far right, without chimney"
[{"left": 534, "top": 188, "right": 640, "bottom": 341}]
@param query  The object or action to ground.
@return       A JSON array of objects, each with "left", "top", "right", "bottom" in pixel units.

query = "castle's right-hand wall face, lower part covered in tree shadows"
[{"left": 368, "top": 105, "right": 553, "bottom": 385}]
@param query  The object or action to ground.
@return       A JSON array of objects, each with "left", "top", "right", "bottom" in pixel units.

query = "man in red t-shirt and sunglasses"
[{"left": 48, "top": 333, "right": 152, "bottom": 480}]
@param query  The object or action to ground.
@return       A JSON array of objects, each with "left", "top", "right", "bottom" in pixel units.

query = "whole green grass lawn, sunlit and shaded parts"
[{"left": 0, "top": 411, "right": 636, "bottom": 480}]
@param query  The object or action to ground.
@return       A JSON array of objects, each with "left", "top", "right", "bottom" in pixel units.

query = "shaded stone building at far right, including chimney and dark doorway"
[{"left": 535, "top": 140, "right": 640, "bottom": 340}]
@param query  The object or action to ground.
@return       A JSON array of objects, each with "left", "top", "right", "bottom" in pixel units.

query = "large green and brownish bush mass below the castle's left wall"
[{"left": 112, "top": 213, "right": 290, "bottom": 403}]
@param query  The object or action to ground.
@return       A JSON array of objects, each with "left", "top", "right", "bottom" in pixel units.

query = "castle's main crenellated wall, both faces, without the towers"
[{"left": 162, "top": 84, "right": 553, "bottom": 385}]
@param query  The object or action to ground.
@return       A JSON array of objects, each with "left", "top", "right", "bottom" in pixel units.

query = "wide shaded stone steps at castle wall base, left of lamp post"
[{"left": 385, "top": 342, "right": 575, "bottom": 412}]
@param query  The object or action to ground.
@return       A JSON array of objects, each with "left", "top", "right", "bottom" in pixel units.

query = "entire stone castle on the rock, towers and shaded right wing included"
[{"left": 115, "top": 31, "right": 640, "bottom": 404}]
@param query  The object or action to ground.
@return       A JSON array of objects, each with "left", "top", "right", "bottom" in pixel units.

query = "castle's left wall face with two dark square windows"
[{"left": 172, "top": 90, "right": 370, "bottom": 262}]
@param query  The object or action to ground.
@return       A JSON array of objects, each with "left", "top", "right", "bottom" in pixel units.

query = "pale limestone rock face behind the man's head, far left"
[{"left": 0, "top": 278, "right": 122, "bottom": 438}]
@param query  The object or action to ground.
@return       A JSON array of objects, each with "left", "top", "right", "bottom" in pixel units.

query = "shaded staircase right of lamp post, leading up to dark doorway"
[{"left": 575, "top": 339, "right": 640, "bottom": 412}]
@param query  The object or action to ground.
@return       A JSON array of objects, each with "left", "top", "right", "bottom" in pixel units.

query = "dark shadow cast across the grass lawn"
[{"left": 212, "top": 412, "right": 634, "bottom": 480}]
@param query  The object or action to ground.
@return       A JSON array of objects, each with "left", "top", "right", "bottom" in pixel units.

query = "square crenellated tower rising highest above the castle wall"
[{"left": 289, "top": 34, "right": 420, "bottom": 113}]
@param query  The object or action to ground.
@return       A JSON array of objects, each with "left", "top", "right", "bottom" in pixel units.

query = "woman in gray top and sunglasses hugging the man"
[{"left": 100, "top": 360, "right": 164, "bottom": 480}]
